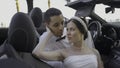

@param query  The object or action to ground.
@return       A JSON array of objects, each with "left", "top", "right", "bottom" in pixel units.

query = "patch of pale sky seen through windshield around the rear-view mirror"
[{"left": 95, "top": 4, "right": 120, "bottom": 21}]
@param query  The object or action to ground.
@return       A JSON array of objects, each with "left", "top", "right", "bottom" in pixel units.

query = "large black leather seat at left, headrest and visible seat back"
[{"left": 8, "top": 12, "right": 52, "bottom": 68}]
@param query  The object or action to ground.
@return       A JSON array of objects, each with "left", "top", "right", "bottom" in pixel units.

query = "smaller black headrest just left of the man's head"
[{"left": 29, "top": 7, "right": 42, "bottom": 28}]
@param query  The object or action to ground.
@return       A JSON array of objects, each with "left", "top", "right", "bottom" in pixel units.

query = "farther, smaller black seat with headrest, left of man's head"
[{"left": 29, "top": 7, "right": 46, "bottom": 35}]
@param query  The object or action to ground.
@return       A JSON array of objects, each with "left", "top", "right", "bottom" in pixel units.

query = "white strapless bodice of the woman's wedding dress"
[{"left": 64, "top": 55, "right": 98, "bottom": 68}]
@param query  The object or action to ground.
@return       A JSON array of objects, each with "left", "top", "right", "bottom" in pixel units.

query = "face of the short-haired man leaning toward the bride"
[{"left": 47, "top": 14, "right": 64, "bottom": 37}]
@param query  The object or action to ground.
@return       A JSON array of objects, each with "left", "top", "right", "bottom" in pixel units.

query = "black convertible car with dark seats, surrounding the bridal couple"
[{"left": 0, "top": 0, "right": 120, "bottom": 68}]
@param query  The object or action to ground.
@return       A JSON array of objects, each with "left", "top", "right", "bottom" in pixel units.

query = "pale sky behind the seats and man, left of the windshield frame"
[{"left": 0, "top": 0, "right": 75, "bottom": 27}]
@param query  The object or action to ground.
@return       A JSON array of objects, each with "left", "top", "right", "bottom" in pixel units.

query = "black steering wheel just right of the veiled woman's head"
[{"left": 88, "top": 21, "right": 102, "bottom": 42}]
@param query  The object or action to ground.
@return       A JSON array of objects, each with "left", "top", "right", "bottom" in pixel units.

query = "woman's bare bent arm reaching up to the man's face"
[{"left": 32, "top": 27, "right": 63, "bottom": 60}]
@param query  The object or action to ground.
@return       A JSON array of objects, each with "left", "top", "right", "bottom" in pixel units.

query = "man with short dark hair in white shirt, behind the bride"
[{"left": 33, "top": 8, "right": 69, "bottom": 68}]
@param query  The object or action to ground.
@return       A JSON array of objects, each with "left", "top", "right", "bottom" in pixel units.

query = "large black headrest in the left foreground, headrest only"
[{"left": 8, "top": 12, "right": 37, "bottom": 52}]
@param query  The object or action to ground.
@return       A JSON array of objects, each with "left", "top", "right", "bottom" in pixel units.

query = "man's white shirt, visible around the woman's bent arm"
[{"left": 39, "top": 29, "right": 70, "bottom": 68}]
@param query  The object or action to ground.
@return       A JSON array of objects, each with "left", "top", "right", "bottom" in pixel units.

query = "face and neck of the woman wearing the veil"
[{"left": 67, "top": 21, "right": 83, "bottom": 43}]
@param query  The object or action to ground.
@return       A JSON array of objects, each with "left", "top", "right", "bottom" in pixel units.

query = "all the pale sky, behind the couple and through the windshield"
[{"left": 0, "top": 0, "right": 120, "bottom": 27}]
